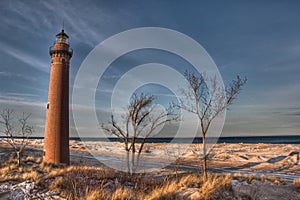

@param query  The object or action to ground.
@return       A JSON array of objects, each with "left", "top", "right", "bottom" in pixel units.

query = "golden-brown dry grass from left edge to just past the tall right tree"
[{"left": 0, "top": 157, "right": 230, "bottom": 200}]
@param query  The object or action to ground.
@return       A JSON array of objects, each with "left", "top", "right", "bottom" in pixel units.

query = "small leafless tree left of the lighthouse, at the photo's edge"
[{"left": 0, "top": 109, "right": 33, "bottom": 165}]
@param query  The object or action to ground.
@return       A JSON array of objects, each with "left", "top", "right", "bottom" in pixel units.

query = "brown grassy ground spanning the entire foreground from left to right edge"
[{"left": 0, "top": 143, "right": 300, "bottom": 200}]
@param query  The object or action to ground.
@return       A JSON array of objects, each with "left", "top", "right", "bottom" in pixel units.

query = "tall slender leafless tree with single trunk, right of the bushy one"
[{"left": 178, "top": 71, "right": 247, "bottom": 179}]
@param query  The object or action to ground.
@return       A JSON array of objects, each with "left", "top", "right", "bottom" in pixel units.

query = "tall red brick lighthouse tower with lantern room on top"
[{"left": 43, "top": 29, "right": 73, "bottom": 165}]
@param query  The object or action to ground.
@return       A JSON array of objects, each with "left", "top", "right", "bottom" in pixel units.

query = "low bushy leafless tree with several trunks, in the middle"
[{"left": 101, "top": 93, "right": 178, "bottom": 154}]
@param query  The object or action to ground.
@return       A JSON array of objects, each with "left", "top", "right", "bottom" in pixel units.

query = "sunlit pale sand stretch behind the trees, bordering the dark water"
[{"left": 12, "top": 139, "right": 300, "bottom": 176}]
